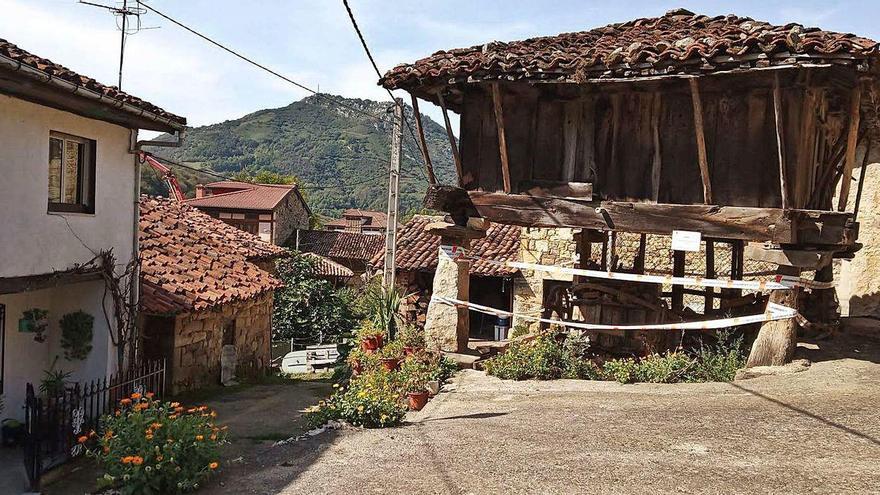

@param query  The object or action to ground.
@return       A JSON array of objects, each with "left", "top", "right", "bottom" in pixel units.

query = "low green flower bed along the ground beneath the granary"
[{"left": 485, "top": 332, "right": 746, "bottom": 383}]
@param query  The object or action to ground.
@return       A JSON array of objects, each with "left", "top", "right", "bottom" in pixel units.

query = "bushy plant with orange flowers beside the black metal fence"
[{"left": 88, "top": 394, "right": 226, "bottom": 494}]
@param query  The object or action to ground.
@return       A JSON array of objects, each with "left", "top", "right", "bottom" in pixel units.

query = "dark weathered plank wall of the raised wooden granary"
[{"left": 461, "top": 74, "right": 844, "bottom": 208}]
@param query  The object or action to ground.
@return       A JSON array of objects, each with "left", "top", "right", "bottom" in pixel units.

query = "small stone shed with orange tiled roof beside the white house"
[{"left": 140, "top": 197, "right": 286, "bottom": 393}]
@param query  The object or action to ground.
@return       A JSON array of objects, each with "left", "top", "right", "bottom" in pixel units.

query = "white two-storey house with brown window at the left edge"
[{"left": 0, "top": 39, "right": 186, "bottom": 419}]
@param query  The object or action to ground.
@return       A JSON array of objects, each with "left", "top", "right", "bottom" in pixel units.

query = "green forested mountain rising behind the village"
[{"left": 142, "top": 94, "right": 455, "bottom": 216}]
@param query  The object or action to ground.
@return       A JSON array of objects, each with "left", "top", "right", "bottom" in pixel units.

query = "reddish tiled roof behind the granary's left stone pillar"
[{"left": 370, "top": 215, "right": 520, "bottom": 277}]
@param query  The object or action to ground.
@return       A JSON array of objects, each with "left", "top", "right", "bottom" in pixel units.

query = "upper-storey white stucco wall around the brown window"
[{"left": 0, "top": 95, "right": 135, "bottom": 277}]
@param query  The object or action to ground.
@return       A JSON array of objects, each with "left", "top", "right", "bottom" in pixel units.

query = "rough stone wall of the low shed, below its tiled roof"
[{"left": 172, "top": 292, "right": 274, "bottom": 393}]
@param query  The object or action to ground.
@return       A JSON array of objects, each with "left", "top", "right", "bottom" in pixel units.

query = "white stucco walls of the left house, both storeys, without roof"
[{"left": 0, "top": 95, "right": 135, "bottom": 419}]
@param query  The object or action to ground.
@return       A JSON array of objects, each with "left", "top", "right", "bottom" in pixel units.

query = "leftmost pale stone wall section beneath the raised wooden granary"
[{"left": 511, "top": 227, "right": 577, "bottom": 329}]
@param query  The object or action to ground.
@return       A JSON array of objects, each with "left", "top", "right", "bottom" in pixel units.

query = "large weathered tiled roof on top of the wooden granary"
[{"left": 379, "top": 9, "right": 878, "bottom": 89}]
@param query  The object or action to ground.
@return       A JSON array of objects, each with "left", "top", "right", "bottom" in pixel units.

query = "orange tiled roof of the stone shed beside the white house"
[{"left": 140, "top": 196, "right": 286, "bottom": 314}]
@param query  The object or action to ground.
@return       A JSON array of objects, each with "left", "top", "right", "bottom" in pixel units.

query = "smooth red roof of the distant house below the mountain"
[{"left": 186, "top": 181, "right": 308, "bottom": 211}]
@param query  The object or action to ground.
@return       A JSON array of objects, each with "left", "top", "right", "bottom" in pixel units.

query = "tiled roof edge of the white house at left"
[{"left": 0, "top": 39, "right": 186, "bottom": 125}]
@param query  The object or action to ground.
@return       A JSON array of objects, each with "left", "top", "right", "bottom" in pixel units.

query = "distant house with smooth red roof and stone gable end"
[{"left": 186, "top": 181, "right": 312, "bottom": 246}]
